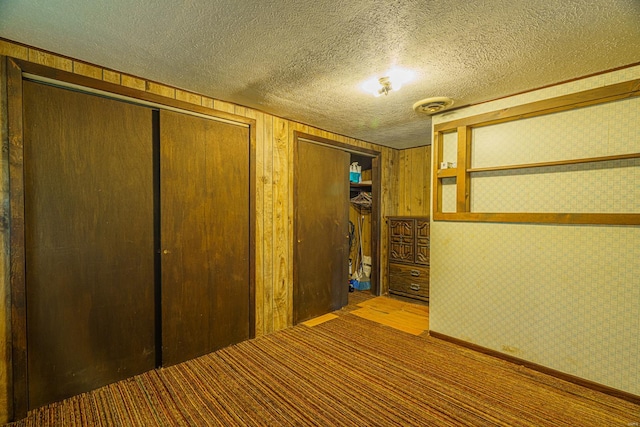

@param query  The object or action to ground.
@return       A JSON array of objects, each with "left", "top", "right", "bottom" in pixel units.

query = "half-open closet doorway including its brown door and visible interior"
[{"left": 293, "top": 131, "right": 381, "bottom": 324}]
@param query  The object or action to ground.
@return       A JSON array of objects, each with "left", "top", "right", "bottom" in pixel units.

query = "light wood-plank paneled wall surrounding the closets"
[{"left": 0, "top": 40, "right": 430, "bottom": 422}]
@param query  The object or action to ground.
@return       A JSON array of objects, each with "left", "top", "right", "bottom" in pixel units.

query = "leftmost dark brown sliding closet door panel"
[{"left": 24, "top": 82, "right": 155, "bottom": 408}]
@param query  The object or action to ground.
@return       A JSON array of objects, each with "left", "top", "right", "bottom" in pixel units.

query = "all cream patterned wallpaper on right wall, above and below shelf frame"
[{"left": 430, "top": 67, "right": 640, "bottom": 395}]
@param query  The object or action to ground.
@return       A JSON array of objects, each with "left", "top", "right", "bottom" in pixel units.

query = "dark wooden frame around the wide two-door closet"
[{"left": 0, "top": 56, "right": 256, "bottom": 419}]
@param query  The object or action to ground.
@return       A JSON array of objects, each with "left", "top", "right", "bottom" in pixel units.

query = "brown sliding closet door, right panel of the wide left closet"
[{"left": 160, "top": 111, "right": 250, "bottom": 365}]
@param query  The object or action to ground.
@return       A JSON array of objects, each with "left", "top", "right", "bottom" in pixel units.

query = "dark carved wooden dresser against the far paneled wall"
[{"left": 387, "top": 216, "right": 429, "bottom": 301}]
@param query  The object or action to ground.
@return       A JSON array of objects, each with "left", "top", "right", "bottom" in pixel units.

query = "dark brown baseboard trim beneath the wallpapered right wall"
[{"left": 429, "top": 331, "right": 640, "bottom": 405}]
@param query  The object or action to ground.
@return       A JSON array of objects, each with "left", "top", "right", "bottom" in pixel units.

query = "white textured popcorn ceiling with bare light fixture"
[{"left": 0, "top": 0, "right": 640, "bottom": 148}]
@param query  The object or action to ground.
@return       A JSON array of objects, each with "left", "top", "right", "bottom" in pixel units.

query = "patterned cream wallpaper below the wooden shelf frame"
[{"left": 429, "top": 222, "right": 640, "bottom": 394}]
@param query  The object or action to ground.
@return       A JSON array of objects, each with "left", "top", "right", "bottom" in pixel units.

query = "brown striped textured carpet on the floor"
[{"left": 8, "top": 310, "right": 640, "bottom": 427}]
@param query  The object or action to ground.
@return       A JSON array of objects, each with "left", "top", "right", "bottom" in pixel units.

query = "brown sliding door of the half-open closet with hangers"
[{"left": 293, "top": 140, "right": 350, "bottom": 324}]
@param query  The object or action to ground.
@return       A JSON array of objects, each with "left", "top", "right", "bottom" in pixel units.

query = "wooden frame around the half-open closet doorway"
[{"left": 292, "top": 130, "right": 382, "bottom": 300}]
